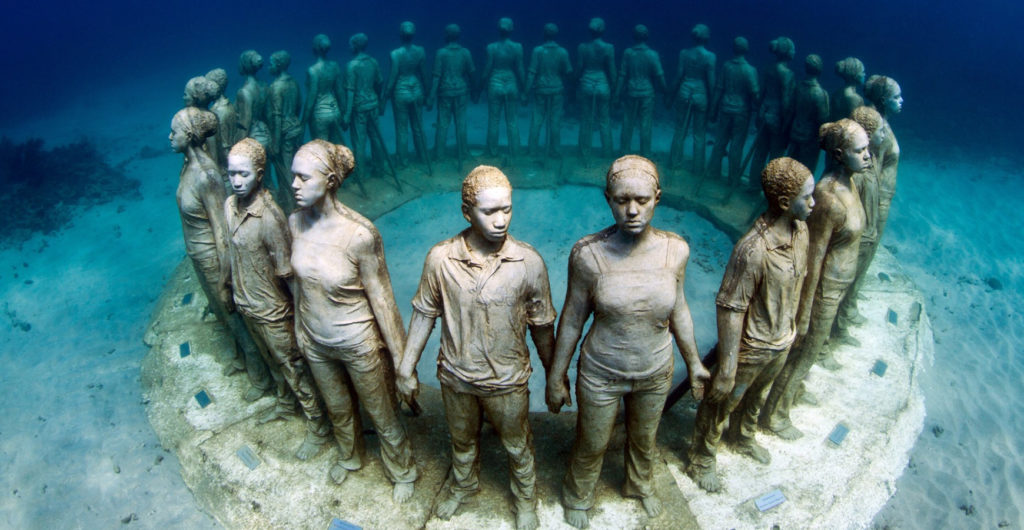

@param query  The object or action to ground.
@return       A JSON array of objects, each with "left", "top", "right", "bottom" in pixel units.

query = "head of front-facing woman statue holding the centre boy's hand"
[{"left": 604, "top": 154, "right": 662, "bottom": 235}]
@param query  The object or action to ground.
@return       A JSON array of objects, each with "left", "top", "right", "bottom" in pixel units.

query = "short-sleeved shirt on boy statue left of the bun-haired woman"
[{"left": 224, "top": 188, "right": 292, "bottom": 322}]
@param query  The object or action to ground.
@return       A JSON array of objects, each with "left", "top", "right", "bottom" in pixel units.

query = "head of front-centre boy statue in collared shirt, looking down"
[{"left": 462, "top": 166, "right": 512, "bottom": 242}]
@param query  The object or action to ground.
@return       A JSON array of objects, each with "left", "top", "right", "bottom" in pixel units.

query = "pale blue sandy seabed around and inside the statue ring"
[{"left": 0, "top": 79, "right": 1024, "bottom": 528}]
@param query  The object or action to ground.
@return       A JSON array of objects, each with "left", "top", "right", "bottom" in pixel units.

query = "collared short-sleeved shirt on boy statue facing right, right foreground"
[{"left": 715, "top": 216, "right": 808, "bottom": 362}]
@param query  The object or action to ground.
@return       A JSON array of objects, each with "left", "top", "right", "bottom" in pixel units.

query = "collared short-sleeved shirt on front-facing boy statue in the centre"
[{"left": 413, "top": 229, "right": 555, "bottom": 395}]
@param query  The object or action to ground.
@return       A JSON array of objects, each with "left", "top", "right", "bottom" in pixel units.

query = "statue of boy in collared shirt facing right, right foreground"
[{"left": 686, "top": 158, "right": 814, "bottom": 492}]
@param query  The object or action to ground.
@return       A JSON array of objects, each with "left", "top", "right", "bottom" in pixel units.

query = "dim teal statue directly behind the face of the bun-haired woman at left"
[{"left": 266, "top": 50, "right": 305, "bottom": 212}]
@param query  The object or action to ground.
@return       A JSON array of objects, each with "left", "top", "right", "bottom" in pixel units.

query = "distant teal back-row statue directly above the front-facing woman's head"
[{"left": 614, "top": 24, "right": 668, "bottom": 157}]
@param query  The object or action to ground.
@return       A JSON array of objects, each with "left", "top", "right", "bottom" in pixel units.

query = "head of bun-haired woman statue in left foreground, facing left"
[{"left": 292, "top": 138, "right": 355, "bottom": 208}]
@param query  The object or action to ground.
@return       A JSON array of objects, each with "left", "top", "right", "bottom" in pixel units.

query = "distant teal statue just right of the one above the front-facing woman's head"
[{"left": 667, "top": 24, "right": 717, "bottom": 175}]
